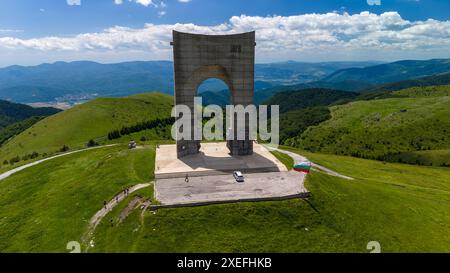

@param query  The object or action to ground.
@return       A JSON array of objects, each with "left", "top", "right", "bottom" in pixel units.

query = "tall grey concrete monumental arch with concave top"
[{"left": 172, "top": 31, "right": 256, "bottom": 158}]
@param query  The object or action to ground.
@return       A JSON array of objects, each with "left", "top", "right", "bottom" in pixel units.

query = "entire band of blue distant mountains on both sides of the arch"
[{"left": 0, "top": 59, "right": 450, "bottom": 104}]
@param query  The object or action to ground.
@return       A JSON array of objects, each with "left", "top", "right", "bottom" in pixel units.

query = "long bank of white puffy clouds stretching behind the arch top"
[{"left": 0, "top": 12, "right": 450, "bottom": 61}]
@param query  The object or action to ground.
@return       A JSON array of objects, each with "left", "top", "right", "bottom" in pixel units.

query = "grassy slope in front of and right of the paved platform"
[{"left": 92, "top": 148, "right": 450, "bottom": 252}]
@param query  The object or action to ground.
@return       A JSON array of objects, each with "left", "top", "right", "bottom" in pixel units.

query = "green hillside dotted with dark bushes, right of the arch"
[{"left": 286, "top": 86, "right": 450, "bottom": 166}]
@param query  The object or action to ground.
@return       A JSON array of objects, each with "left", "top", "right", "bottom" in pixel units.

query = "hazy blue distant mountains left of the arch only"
[{"left": 0, "top": 61, "right": 173, "bottom": 103}]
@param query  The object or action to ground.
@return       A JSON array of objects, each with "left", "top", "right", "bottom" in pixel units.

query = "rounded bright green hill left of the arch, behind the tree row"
[{"left": 0, "top": 93, "right": 173, "bottom": 168}]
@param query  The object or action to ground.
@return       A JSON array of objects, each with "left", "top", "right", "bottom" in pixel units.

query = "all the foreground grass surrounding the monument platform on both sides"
[{"left": 0, "top": 145, "right": 450, "bottom": 252}]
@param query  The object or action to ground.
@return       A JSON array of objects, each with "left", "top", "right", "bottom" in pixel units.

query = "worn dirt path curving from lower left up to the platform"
[{"left": 82, "top": 182, "right": 153, "bottom": 251}]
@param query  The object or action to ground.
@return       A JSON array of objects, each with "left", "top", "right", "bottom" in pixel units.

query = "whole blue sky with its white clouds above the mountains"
[{"left": 0, "top": 0, "right": 450, "bottom": 67}]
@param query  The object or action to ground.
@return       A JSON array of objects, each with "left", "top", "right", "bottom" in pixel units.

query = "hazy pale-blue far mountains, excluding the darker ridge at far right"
[{"left": 0, "top": 61, "right": 377, "bottom": 103}]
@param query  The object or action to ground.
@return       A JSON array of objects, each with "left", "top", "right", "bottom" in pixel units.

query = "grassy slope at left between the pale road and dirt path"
[{"left": 0, "top": 145, "right": 154, "bottom": 252}]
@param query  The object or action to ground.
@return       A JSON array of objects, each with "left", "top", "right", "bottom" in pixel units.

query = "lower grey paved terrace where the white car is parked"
[{"left": 155, "top": 171, "right": 309, "bottom": 207}]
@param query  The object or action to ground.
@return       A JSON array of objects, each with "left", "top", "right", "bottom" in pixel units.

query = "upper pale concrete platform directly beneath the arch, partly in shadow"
[{"left": 155, "top": 142, "right": 287, "bottom": 178}]
